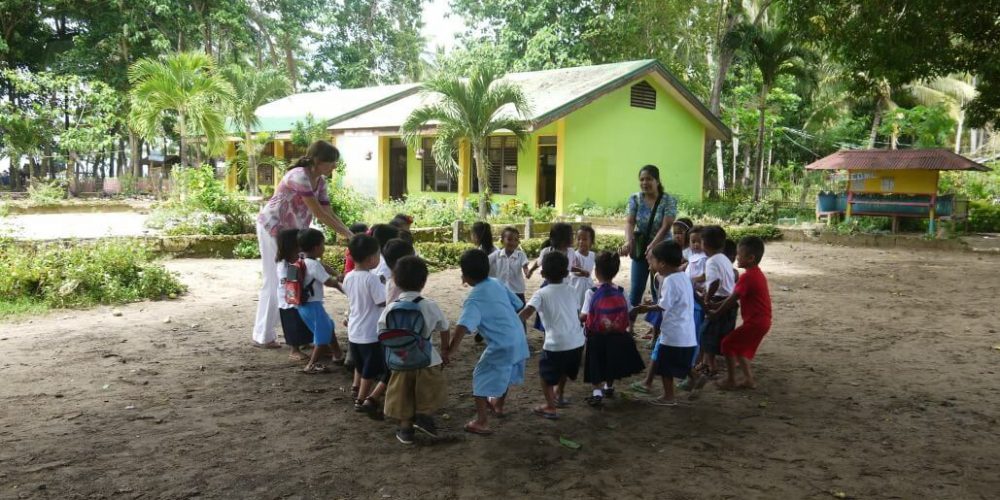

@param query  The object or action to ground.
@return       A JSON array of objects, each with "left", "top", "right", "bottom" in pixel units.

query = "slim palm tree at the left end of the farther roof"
[{"left": 222, "top": 65, "right": 291, "bottom": 194}]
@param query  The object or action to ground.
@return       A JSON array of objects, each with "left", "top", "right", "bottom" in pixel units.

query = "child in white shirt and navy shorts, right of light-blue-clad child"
[{"left": 520, "top": 252, "right": 585, "bottom": 420}]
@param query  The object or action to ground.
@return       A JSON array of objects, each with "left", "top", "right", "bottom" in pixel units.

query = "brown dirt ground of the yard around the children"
[{"left": 0, "top": 243, "right": 1000, "bottom": 499}]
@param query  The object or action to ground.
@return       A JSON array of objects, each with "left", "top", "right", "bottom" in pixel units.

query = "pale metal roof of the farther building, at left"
[{"left": 229, "top": 83, "right": 419, "bottom": 132}]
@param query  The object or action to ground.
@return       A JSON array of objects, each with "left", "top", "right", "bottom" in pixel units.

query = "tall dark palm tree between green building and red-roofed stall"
[{"left": 737, "top": 25, "right": 812, "bottom": 201}]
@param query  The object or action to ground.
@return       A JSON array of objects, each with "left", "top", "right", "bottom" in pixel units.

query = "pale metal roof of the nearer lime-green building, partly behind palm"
[{"left": 330, "top": 60, "right": 730, "bottom": 138}]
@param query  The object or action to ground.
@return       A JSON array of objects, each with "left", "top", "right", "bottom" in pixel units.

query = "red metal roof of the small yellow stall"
[{"left": 806, "top": 149, "right": 990, "bottom": 172}]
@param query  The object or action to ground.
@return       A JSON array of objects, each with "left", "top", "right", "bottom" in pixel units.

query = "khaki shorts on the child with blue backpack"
[{"left": 385, "top": 365, "right": 448, "bottom": 420}]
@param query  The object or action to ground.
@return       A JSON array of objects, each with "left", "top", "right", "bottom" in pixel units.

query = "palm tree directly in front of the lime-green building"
[{"left": 400, "top": 66, "right": 531, "bottom": 219}]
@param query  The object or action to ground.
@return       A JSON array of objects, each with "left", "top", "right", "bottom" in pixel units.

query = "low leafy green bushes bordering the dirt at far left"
[{"left": 0, "top": 240, "right": 185, "bottom": 311}]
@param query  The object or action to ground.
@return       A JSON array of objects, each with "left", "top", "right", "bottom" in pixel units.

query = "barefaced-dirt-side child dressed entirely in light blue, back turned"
[{"left": 445, "top": 249, "right": 528, "bottom": 434}]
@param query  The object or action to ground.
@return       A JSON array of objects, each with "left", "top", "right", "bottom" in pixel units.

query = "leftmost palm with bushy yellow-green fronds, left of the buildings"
[{"left": 128, "top": 52, "right": 233, "bottom": 168}]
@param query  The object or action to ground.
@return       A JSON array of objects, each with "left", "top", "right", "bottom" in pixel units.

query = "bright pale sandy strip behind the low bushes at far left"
[{"left": 0, "top": 212, "right": 155, "bottom": 240}]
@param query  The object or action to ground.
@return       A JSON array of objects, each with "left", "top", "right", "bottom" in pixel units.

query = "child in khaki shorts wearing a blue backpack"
[{"left": 379, "top": 256, "right": 451, "bottom": 444}]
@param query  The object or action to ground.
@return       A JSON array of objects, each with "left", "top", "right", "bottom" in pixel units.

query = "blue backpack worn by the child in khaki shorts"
[{"left": 378, "top": 297, "right": 434, "bottom": 371}]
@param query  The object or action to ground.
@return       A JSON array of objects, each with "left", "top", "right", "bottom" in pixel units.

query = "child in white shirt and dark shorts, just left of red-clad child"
[{"left": 696, "top": 226, "right": 736, "bottom": 380}]
